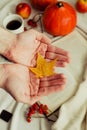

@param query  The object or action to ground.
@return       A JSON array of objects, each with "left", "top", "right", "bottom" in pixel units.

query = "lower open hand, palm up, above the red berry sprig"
[{"left": 0, "top": 64, "right": 66, "bottom": 104}]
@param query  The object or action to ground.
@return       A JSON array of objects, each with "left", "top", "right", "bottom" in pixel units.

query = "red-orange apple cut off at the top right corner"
[{"left": 76, "top": 0, "right": 87, "bottom": 13}]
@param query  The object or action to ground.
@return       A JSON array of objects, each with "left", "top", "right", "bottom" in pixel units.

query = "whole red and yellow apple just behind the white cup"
[{"left": 16, "top": 3, "right": 31, "bottom": 19}]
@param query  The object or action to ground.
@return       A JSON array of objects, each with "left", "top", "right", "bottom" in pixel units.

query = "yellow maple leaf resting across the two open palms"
[{"left": 29, "top": 54, "right": 57, "bottom": 78}]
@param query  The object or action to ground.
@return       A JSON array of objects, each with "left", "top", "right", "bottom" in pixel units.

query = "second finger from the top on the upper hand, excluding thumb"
[{"left": 45, "top": 51, "right": 70, "bottom": 63}]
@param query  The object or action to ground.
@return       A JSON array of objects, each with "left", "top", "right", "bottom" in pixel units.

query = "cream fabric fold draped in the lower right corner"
[{"left": 52, "top": 67, "right": 87, "bottom": 130}]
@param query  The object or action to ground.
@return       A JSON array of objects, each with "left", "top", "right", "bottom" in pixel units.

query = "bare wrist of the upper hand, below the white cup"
[{"left": 0, "top": 27, "right": 16, "bottom": 56}]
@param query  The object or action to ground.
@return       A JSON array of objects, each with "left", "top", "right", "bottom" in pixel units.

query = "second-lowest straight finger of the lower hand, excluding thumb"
[{"left": 40, "top": 79, "right": 66, "bottom": 88}]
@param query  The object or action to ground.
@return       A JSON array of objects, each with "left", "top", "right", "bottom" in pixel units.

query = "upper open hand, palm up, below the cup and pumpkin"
[{"left": 4, "top": 30, "right": 69, "bottom": 67}]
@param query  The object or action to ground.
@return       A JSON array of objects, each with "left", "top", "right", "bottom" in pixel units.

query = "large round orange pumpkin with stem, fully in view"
[{"left": 42, "top": 1, "right": 77, "bottom": 36}]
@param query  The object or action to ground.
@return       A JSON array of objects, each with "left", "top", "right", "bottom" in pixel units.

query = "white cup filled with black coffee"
[{"left": 3, "top": 14, "right": 24, "bottom": 34}]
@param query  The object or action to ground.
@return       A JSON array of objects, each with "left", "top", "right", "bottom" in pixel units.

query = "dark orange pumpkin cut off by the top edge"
[{"left": 30, "top": 0, "right": 57, "bottom": 11}]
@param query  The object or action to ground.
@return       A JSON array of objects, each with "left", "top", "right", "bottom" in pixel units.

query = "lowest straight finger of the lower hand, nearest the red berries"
[{"left": 38, "top": 85, "right": 65, "bottom": 96}]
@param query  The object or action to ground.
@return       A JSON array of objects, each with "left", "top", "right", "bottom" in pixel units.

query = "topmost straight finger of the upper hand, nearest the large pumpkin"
[{"left": 47, "top": 45, "right": 69, "bottom": 56}]
